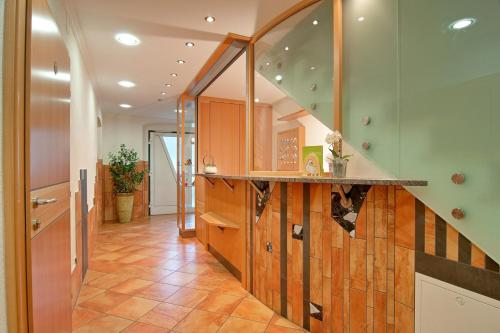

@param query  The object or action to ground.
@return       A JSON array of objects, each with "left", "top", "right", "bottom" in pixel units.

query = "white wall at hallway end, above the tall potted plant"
[{"left": 102, "top": 113, "right": 175, "bottom": 163}]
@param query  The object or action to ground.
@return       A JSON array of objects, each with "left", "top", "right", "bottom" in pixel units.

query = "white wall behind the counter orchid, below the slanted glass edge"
[{"left": 272, "top": 97, "right": 391, "bottom": 178}]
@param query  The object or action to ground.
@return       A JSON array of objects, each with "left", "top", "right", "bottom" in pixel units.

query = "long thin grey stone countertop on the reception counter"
[{"left": 196, "top": 172, "right": 427, "bottom": 186}]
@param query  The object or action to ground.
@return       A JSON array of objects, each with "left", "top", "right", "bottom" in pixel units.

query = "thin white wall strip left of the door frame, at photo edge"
[{"left": 0, "top": 0, "right": 7, "bottom": 332}]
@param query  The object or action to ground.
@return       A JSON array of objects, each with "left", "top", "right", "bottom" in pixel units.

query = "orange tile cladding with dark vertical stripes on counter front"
[{"left": 248, "top": 183, "right": 500, "bottom": 332}]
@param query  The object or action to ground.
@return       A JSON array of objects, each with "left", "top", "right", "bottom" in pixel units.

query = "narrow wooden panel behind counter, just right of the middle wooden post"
[{"left": 252, "top": 103, "right": 273, "bottom": 171}]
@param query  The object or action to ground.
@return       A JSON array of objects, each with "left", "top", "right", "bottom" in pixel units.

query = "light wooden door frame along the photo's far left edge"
[{"left": 2, "top": 0, "right": 31, "bottom": 333}]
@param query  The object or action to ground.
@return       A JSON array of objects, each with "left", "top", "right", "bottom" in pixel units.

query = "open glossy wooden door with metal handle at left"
[{"left": 26, "top": 0, "right": 71, "bottom": 333}]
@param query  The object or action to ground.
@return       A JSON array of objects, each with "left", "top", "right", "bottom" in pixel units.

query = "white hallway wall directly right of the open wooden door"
[{"left": 49, "top": 0, "right": 101, "bottom": 269}]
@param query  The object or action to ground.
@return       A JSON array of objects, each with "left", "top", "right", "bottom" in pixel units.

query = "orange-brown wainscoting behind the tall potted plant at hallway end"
[{"left": 102, "top": 161, "right": 149, "bottom": 223}]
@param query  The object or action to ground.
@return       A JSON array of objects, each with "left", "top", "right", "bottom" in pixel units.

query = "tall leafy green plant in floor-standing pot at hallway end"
[{"left": 108, "top": 144, "right": 147, "bottom": 223}]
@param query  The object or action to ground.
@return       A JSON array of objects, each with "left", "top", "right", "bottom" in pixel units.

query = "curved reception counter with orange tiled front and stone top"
[{"left": 196, "top": 173, "right": 500, "bottom": 332}]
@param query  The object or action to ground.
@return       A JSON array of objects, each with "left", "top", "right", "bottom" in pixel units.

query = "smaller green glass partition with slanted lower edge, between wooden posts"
[{"left": 255, "top": 0, "right": 333, "bottom": 128}]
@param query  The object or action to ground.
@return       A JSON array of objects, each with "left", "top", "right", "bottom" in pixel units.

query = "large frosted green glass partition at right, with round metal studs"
[{"left": 343, "top": 0, "right": 500, "bottom": 261}]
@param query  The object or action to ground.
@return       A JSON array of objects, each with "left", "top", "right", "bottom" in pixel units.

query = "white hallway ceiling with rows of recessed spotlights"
[{"left": 68, "top": 0, "right": 299, "bottom": 121}]
